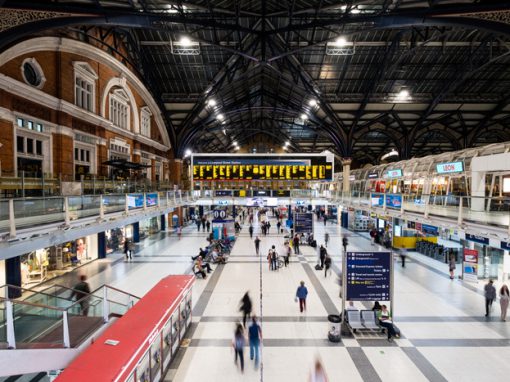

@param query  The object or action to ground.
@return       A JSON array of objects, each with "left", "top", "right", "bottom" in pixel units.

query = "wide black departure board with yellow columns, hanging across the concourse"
[{"left": 192, "top": 154, "right": 333, "bottom": 181}]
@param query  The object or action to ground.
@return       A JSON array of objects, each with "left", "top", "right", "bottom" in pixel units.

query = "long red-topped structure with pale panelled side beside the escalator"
[{"left": 56, "top": 275, "right": 194, "bottom": 382}]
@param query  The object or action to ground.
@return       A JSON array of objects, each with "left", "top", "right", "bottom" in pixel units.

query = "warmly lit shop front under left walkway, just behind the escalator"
[{"left": 20, "top": 235, "right": 98, "bottom": 288}]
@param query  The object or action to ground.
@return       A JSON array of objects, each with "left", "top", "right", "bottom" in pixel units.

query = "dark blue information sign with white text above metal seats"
[{"left": 346, "top": 252, "right": 391, "bottom": 301}]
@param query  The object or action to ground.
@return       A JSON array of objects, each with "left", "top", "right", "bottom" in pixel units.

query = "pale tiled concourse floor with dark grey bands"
[{"left": 42, "top": 213, "right": 510, "bottom": 382}]
